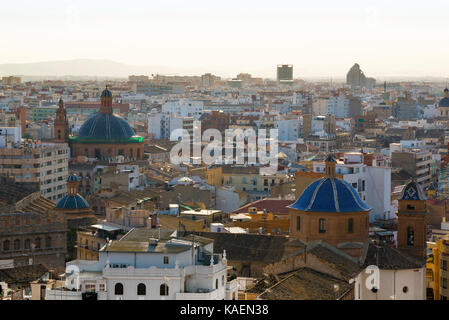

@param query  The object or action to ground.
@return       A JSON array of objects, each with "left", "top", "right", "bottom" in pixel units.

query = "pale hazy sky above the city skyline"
[{"left": 0, "top": 0, "right": 449, "bottom": 78}]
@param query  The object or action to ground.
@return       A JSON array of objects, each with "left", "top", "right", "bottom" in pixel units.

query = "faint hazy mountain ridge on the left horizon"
[{"left": 0, "top": 59, "right": 206, "bottom": 77}]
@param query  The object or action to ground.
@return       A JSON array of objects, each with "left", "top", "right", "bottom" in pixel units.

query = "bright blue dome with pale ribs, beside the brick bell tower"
[{"left": 290, "top": 178, "right": 371, "bottom": 212}]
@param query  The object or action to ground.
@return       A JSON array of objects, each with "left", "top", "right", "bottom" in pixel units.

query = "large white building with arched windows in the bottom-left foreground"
[{"left": 46, "top": 228, "right": 238, "bottom": 300}]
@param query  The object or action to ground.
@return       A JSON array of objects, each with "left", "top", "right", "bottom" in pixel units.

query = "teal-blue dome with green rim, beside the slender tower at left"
[{"left": 77, "top": 113, "right": 135, "bottom": 140}]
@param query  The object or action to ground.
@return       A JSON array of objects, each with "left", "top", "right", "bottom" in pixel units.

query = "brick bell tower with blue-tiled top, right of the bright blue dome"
[{"left": 398, "top": 179, "right": 427, "bottom": 259}]
